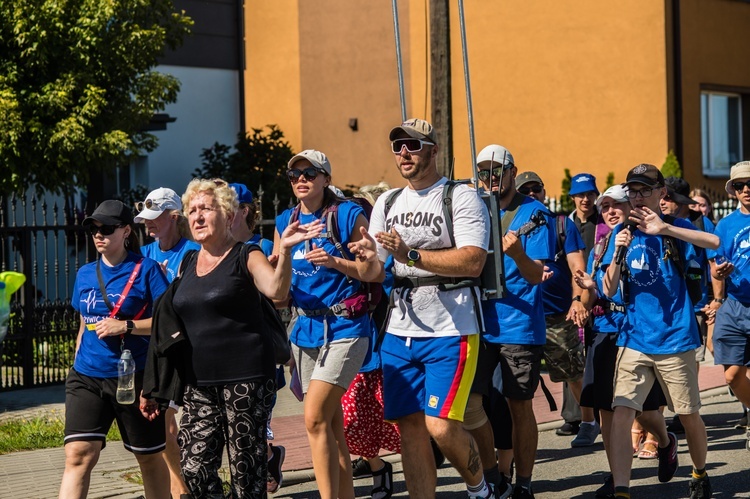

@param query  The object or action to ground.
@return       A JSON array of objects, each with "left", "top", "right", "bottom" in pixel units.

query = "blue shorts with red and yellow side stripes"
[{"left": 380, "top": 334, "right": 479, "bottom": 422}]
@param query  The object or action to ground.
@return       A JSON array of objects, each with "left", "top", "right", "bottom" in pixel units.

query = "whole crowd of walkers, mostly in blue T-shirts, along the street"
[{"left": 60, "top": 119, "right": 750, "bottom": 499}]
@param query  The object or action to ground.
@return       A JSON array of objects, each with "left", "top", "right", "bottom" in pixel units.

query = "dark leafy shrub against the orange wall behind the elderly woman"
[{"left": 193, "top": 125, "right": 294, "bottom": 219}]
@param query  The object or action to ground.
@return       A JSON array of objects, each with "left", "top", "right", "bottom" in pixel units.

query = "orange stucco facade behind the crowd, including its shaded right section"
[{"left": 245, "top": 0, "right": 750, "bottom": 195}]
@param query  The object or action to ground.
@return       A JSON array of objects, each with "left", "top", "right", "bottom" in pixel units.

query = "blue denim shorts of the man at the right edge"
[{"left": 714, "top": 298, "right": 750, "bottom": 366}]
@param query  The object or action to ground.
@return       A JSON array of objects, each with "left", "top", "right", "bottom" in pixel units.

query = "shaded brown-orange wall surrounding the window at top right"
[{"left": 680, "top": 0, "right": 750, "bottom": 191}]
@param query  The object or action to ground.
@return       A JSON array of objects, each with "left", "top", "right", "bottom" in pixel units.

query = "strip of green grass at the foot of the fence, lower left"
[{"left": 0, "top": 412, "right": 122, "bottom": 455}]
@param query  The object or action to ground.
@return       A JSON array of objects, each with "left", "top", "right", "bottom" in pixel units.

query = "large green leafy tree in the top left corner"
[{"left": 0, "top": 0, "right": 192, "bottom": 192}]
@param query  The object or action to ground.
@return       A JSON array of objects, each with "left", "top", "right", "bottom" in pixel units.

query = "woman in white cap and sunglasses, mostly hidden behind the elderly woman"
[{"left": 135, "top": 187, "right": 200, "bottom": 497}]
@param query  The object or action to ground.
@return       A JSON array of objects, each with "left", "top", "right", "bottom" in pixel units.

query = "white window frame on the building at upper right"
[{"left": 700, "top": 91, "right": 744, "bottom": 177}]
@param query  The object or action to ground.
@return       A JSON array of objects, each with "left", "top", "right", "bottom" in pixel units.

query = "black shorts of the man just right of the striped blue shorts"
[{"left": 471, "top": 342, "right": 544, "bottom": 400}]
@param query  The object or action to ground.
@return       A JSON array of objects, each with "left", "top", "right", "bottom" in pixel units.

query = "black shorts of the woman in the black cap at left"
[{"left": 65, "top": 369, "right": 166, "bottom": 454}]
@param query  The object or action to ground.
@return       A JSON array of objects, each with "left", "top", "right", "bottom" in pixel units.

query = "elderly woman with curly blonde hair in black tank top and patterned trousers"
[{"left": 172, "top": 179, "right": 322, "bottom": 498}]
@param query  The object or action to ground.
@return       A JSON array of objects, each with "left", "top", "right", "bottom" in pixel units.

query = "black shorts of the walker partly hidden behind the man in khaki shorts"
[{"left": 581, "top": 333, "right": 667, "bottom": 411}]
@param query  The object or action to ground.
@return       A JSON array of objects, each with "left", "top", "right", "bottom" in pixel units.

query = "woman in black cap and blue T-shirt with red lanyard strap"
[{"left": 60, "top": 200, "right": 169, "bottom": 499}]
